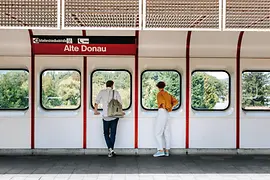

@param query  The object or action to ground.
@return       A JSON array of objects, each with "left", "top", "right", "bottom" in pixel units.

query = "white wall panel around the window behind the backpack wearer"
[{"left": 87, "top": 56, "right": 135, "bottom": 148}]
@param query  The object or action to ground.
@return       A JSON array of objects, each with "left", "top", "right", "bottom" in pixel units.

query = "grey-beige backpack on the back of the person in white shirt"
[{"left": 108, "top": 90, "right": 123, "bottom": 117}]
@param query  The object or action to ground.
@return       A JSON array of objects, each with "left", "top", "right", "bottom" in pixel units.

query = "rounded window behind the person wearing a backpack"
[{"left": 91, "top": 69, "right": 132, "bottom": 110}]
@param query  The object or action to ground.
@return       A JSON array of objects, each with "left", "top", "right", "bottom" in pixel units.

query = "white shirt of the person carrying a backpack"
[{"left": 96, "top": 87, "right": 122, "bottom": 121}]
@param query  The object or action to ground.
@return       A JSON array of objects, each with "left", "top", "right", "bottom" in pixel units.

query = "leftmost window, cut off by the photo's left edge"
[{"left": 0, "top": 69, "right": 29, "bottom": 110}]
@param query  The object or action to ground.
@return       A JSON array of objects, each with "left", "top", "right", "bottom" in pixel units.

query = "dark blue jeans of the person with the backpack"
[{"left": 103, "top": 118, "right": 119, "bottom": 149}]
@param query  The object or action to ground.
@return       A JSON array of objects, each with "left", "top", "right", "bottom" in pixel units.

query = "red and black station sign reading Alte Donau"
[{"left": 32, "top": 36, "right": 136, "bottom": 55}]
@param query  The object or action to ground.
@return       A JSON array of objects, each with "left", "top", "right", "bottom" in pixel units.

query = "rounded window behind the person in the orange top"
[{"left": 141, "top": 70, "right": 181, "bottom": 110}]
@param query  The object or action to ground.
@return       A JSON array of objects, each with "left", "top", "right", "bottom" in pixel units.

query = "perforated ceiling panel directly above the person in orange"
[{"left": 144, "top": 0, "right": 222, "bottom": 30}]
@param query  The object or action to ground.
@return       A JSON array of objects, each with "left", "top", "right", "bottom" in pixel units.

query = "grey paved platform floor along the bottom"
[{"left": 0, "top": 155, "right": 270, "bottom": 180}]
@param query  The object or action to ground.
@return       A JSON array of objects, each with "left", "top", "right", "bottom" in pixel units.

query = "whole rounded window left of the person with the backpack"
[{"left": 41, "top": 70, "right": 81, "bottom": 110}]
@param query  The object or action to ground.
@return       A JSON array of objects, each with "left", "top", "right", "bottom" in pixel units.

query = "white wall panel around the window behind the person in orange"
[{"left": 139, "top": 58, "right": 186, "bottom": 148}]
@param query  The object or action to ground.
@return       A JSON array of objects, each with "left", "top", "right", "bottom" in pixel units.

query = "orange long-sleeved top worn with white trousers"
[{"left": 157, "top": 91, "right": 178, "bottom": 112}]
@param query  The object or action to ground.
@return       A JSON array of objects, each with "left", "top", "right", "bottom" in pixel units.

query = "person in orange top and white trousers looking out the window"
[{"left": 153, "top": 82, "right": 178, "bottom": 157}]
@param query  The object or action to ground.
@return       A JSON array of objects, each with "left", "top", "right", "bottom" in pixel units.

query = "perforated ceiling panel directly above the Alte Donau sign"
[{"left": 63, "top": 0, "right": 141, "bottom": 30}]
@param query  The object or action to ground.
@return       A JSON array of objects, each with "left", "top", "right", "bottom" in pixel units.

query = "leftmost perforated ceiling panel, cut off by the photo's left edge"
[{"left": 0, "top": 0, "right": 60, "bottom": 29}]
